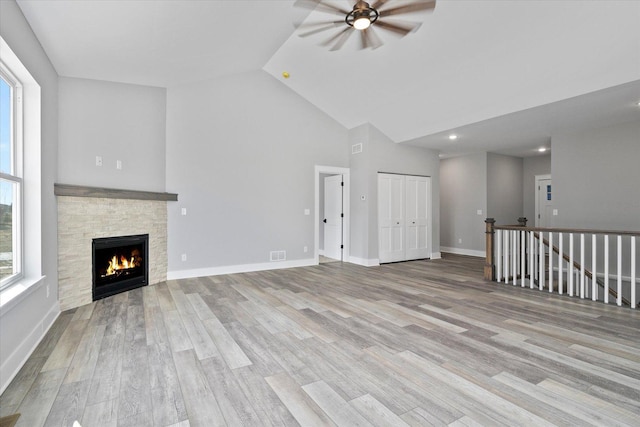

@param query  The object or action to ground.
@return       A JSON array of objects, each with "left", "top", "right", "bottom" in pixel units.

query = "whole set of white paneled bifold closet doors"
[{"left": 378, "top": 173, "right": 431, "bottom": 263}]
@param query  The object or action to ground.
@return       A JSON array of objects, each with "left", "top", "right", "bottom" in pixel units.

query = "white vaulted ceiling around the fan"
[{"left": 18, "top": 0, "right": 640, "bottom": 156}]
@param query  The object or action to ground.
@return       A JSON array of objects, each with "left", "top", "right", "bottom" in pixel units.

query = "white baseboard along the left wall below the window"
[{"left": 0, "top": 298, "right": 60, "bottom": 394}]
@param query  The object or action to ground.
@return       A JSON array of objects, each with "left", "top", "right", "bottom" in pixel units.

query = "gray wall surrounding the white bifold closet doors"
[{"left": 349, "top": 124, "right": 440, "bottom": 262}]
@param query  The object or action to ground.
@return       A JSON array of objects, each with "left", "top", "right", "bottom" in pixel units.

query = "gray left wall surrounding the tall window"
[{"left": 0, "top": 1, "right": 59, "bottom": 390}]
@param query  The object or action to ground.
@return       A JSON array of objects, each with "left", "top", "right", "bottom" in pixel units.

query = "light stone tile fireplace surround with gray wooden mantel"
[{"left": 54, "top": 184, "right": 178, "bottom": 310}]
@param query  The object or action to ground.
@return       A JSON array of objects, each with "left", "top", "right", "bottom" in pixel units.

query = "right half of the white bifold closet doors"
[{"left": 405, "top": 176, "right": 431, "bottom": 260}]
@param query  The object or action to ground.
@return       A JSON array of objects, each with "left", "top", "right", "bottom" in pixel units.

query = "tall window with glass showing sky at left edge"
[{"left": 0, "top": 62, "right": 22, "bottom": 289}]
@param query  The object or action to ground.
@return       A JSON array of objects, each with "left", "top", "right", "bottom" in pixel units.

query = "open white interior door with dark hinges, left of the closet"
[{"left": 323, "top": 175, "right": 343, "bottom": 261}]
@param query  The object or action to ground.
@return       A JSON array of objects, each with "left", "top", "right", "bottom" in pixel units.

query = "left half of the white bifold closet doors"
[{"left": 378, "top": 173, "right": 405, "bottom": 263}]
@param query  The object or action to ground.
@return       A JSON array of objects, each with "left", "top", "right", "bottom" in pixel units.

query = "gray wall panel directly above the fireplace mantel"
[{"left": 58, "top": 77, "right": 166, "bottom": 191}]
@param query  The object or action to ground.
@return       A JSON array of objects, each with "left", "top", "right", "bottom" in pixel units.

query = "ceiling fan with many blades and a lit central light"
[{"left": 294, "top": 0, "right": 436, "bottom": 50}]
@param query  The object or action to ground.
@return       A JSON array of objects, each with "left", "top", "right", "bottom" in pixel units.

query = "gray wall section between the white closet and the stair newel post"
[{"left": 440, "top": 153, "right": 487, "bottom": 255}]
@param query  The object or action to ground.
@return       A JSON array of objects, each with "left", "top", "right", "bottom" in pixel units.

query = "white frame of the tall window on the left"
[{"left": 0, "top": 61, "right": 24, "bottom": 291}]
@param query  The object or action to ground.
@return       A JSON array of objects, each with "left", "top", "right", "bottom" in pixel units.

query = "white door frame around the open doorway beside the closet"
[{"left": 313, "top": 165, "right": 350, "bottom": 265}]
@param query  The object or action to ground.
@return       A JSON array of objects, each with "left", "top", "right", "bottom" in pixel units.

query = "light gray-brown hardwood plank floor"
[{"left": 0, "top": 255, "right": 640, "bottom": 427}]
